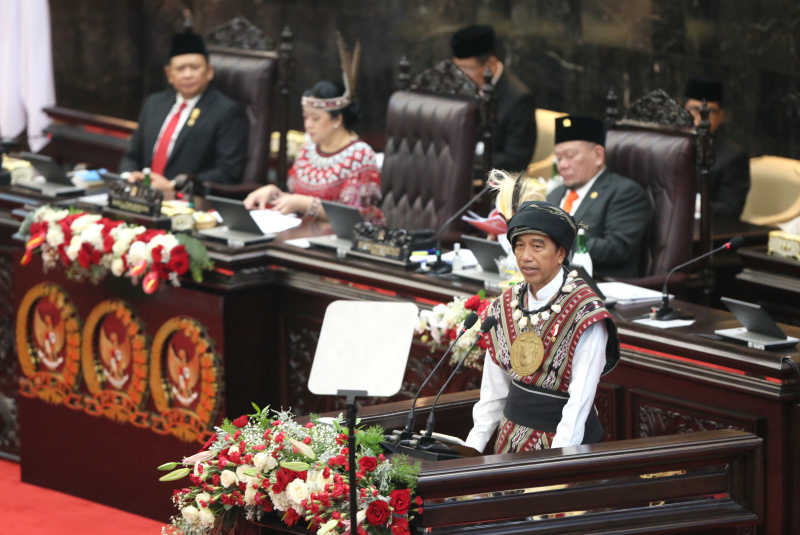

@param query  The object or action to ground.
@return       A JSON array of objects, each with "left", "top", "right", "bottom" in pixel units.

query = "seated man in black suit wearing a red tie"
[{"left": 120, "top": 32, "right": 248, "bottom": 191}]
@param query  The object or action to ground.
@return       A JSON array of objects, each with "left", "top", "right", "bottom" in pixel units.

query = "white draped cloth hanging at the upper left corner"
[{"left": 0, "top": 0, "right": 56, "bottom": 152}]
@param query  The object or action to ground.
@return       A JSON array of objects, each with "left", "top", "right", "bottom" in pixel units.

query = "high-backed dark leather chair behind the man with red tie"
[{"left": 206, "top": 17, "right": 292, "bottom": 198}]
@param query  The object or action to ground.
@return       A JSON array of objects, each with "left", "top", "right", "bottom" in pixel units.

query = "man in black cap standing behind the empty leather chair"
[{"left": 450, "top": 26, "right": 536, "bottom": 171}]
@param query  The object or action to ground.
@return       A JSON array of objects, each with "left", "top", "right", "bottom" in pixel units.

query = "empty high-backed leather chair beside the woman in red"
[{"left": 381, "top": 61, "right": 491, "bottom": 242}]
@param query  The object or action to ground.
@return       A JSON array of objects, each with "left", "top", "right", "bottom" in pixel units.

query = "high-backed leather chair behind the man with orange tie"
[{"left": 606, "top": 90, "right": 708, "bottom": 289}]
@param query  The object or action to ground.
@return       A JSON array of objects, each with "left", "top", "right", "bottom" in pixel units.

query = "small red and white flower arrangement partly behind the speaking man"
[{"left": 416, "top": 290, "right": 492, "bottom": 370}]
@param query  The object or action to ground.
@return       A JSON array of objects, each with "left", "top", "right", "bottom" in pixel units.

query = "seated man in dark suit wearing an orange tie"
[{"left": 547, "top": 116, "right": 651, "bottom": 278}]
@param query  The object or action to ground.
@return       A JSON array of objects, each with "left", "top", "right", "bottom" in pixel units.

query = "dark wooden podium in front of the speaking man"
[{"left": 250, "top": 391, "right": 764, "bottom": 535}]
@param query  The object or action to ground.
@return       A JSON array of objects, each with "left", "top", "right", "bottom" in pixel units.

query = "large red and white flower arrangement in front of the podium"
[{"left": 159, "top": 405, "right": 422, "bottom": 535}]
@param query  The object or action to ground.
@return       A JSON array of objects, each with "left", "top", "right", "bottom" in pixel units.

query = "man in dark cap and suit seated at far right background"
[{"left": 685, "top": 78, "right": 750, "bottom": 219}]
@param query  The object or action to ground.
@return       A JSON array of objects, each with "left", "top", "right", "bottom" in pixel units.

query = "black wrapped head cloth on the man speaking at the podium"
[{"left": 506, "top": 201, "right": 578, "bottom": 251}]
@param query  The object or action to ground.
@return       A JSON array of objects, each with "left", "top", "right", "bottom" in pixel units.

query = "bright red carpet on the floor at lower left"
[{"left": 0, "top": 459, "right": 167, "bottom": 535}]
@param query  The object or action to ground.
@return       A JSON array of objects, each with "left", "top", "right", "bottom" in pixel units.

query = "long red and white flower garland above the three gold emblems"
[{"left": 19, "top": 206, "right": 213, "bottom": 293}]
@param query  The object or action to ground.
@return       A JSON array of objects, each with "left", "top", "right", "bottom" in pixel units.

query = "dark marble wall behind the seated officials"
[{"left": 50, "top": 0, "right": 800, "bottom": 159}]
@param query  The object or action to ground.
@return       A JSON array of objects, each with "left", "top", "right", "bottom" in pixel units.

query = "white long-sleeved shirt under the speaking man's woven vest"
[{"left": 466, "top": 271, "right": 608, "bottom": 451}]
